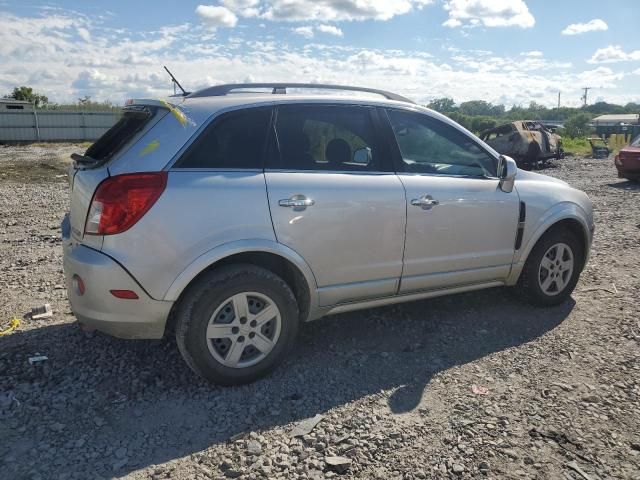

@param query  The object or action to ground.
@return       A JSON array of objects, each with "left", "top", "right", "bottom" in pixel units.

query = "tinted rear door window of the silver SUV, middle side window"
[{"left": 268, "top": 105, "right": 384, "bottom": 171}]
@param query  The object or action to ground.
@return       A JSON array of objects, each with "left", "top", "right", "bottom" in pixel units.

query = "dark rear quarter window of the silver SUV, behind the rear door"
[{"left": 174, "top": 108, "right": 271, "bottom": 169}]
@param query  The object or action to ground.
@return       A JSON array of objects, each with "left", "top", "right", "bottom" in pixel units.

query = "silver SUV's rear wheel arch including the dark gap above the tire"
[{"left": 164, "top": 240, "right": 318, "bottom": 325}]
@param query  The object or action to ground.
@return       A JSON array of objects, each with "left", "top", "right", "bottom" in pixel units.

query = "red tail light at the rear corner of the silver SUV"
[{"left": 84, "top": 172, "right": 167, "bottom": 235}]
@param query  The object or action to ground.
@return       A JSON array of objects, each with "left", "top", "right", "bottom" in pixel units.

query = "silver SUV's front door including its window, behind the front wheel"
[{"left": 387, "top": 109, "right": 519, "bottom": 293}]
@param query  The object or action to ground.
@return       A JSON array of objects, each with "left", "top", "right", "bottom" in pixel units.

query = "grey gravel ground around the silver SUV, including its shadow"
[{"left": 0, "top": 145, "right": 640, "bottom": 479}]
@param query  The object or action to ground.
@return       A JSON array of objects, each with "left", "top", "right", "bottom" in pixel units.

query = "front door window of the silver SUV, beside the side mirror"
[{"left": 387, "top": 110, "right": 497, "bottom": 177}]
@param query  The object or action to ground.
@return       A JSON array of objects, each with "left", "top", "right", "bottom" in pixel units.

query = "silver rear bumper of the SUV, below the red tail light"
[{"left": 62, "top": 216, "right": 173, "bottom": 339}]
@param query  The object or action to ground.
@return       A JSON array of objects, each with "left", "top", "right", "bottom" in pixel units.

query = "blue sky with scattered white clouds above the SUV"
[{"left": 0, "top": 0, "right": 640, "bottom": 108}]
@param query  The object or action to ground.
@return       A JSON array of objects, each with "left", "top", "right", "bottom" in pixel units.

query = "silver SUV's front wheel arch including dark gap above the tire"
[{"left": 506, "top": 203, "right": 591, "bottom": 285}]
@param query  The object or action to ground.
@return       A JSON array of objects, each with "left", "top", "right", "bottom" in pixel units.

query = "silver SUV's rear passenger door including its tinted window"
[{"left": 265, "top": 104, "right": 406, "bottom": 306}]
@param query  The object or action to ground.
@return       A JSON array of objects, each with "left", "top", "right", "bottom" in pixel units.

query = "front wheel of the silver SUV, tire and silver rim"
[{"left": 513, "top": 228, "right": 584, "bottom": 307}]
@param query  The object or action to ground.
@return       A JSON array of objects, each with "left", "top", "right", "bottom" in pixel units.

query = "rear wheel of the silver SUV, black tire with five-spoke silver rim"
[{"left": 176, "top": 264, "right": 299, "bottom": 385}]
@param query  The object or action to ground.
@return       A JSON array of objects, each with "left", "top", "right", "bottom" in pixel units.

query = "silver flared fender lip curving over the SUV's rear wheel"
[{"left": 164, "top": 238, "right": 318, "bottom": 316}]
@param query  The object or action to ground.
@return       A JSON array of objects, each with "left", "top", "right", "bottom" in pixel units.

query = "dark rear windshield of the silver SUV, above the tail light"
[{"left": 85, "top": 105, "right": 157, "bottom": 162}]
